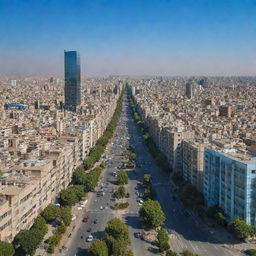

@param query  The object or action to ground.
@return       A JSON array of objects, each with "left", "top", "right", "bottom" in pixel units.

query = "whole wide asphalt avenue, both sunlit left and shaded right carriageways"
[{"left": 65, "top": 96, "right": 239, "bottom": 256}]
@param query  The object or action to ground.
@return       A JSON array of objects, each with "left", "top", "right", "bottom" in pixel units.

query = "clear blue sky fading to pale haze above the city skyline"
[{"left": 0, "top": 0, "right": 256, "bottom": 76}]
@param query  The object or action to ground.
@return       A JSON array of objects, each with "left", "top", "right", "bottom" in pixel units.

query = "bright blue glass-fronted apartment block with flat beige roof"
[{"left": 204, "top": 148, "right": 256, "bottom": 225}]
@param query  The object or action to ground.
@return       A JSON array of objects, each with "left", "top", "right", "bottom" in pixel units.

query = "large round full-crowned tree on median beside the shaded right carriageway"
[{"left": 139, "top": 199, "right": 165, "bottom": 228}]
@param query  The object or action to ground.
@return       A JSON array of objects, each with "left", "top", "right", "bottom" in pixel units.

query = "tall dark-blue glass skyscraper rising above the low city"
[{"left": 64, "top": 51, "right": 81, "bottom": 112}]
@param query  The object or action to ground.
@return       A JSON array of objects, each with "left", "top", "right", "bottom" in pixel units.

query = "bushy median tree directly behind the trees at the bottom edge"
[{"left": 105, "top": 218, "right": 130, "bottom": 244}]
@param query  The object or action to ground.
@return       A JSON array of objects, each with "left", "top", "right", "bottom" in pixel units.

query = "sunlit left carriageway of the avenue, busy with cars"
[{"left": 63, "top": 95, "right": 155, "bottom": 256}]
